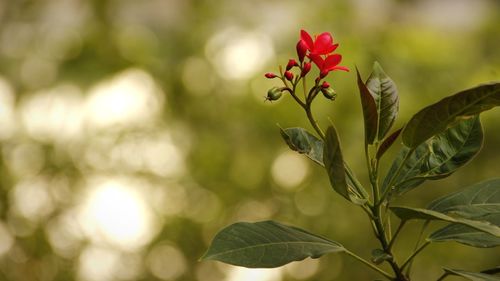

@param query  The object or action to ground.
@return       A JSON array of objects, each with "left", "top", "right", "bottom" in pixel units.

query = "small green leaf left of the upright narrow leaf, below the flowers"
[{"left": 280, "top": 128, "right": 324, "bottom": 166}]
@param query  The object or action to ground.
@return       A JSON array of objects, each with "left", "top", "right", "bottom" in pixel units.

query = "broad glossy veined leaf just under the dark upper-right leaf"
[{"left": 382, "top": 116, "right": 483, "bottom": 194}]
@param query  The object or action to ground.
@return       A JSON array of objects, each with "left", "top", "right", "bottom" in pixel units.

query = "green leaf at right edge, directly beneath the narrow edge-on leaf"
[{"left": 427, "top": 213, "right": 500, "bottom": 248}]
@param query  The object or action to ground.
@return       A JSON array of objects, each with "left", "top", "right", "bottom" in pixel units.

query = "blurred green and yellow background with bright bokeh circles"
[{"left": 0, "top": 0, "right": 500, "bottom": 281}]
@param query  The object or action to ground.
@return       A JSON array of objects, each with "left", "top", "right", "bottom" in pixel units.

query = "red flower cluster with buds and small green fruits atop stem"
[{"left": 265, "top": 30, "right": 349, "bottom": 102}]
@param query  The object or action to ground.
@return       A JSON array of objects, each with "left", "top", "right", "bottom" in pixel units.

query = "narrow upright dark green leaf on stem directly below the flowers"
[{"left": 323, "top": 126, "right": 351, "bottom": 201}]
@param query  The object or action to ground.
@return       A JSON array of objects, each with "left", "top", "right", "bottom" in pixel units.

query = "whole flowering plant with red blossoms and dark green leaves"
[{"left": 202, "top": 30, "right": 500, "bottom": 280}]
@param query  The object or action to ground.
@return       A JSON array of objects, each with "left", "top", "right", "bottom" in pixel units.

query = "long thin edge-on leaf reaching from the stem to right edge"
[{"left": 390, "top": 207, "right": 500, "bottom": 237}]
